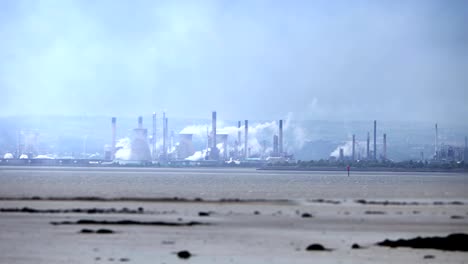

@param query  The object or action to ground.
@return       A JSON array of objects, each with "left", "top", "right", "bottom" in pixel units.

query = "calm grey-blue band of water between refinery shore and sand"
[{"left": 0, "top": 167, "right": 468, "bottom": 199}]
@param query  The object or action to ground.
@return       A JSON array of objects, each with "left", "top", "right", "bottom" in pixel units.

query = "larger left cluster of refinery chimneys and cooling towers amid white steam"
[{"left": 1, "top": 111, "right": 294, "bottom": 166}]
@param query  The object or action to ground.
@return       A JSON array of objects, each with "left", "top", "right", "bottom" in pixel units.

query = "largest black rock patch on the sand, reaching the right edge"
[{"left": 377, "top": 234, "right": 468, "bottom": 251}]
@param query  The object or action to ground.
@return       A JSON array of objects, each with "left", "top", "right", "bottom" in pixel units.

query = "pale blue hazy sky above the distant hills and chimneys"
[{"left": 0, "top": 0, "right": 468, "bottom": 122}]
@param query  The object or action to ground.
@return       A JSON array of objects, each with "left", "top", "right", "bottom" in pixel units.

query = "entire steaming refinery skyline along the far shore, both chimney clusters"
[{"left": 0, "top": 111, "right": 468, "bottom": 167}]
